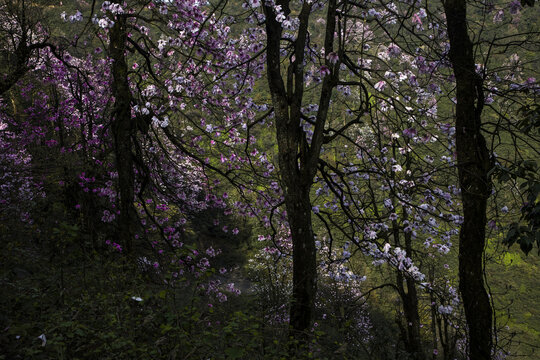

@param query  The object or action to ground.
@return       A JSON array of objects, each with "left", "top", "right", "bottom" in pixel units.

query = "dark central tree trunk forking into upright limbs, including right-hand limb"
[{"left": 265, "top": 0, "right": 337, "bottom": 340}]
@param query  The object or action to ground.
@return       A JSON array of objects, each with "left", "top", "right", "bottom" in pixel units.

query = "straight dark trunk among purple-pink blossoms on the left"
[{"left": 109, "top": 15, "right": 135, "bottom": 252}]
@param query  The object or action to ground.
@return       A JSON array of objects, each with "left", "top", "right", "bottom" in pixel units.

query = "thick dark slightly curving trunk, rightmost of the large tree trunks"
[{"left": 444, "top": 0, "right": 493, "bottom": 360}]
